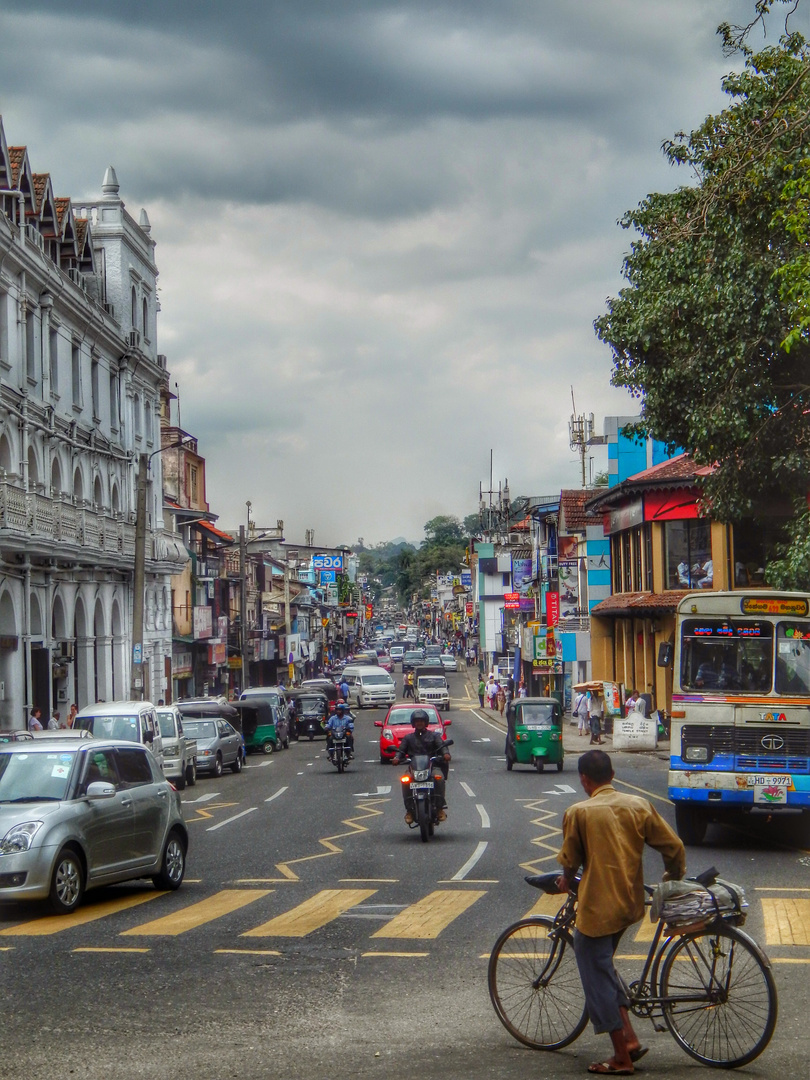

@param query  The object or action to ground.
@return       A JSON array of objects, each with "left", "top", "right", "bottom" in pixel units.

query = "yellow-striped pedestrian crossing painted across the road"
[{"left": 0, "top": 880, "right": 810, "bottom": 962}]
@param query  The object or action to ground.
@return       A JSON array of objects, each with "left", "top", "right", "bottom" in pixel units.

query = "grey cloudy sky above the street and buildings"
[{"left": 0, "top": 0, "right": 775, "bottom": 543}]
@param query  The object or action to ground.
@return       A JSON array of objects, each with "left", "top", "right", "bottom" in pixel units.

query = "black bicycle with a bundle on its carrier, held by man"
[{"left": 487, "top": 868, "right": 778, "bottom": 1068}]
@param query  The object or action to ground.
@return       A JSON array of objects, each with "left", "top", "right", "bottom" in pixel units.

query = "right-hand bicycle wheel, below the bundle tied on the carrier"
[{"left": 660, "top": 923, "right": 777, "bottom": 1069}]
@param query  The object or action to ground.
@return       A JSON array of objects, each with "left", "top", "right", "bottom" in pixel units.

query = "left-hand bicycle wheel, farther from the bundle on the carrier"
[{"left": 487, "top": 915, "right": 588, "bottom": 1050}]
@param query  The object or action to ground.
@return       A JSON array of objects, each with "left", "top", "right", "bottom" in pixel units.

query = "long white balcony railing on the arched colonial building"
[{"left": 0, "top": 481, "right": 138, "bottom": 558}]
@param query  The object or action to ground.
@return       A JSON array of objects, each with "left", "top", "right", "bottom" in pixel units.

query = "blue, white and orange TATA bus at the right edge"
[{"left": 659, "top": 591, "right": 810, "bottom": 845}]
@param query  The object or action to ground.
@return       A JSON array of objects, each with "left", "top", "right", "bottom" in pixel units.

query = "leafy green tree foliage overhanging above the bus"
[{"left": 595, "top": 27, "right": 810, "bottom": 585}]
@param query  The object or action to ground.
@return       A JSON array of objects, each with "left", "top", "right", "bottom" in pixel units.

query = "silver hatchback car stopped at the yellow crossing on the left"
[{"left": 0, "top": 739, "right": 188, "bottom": 915}]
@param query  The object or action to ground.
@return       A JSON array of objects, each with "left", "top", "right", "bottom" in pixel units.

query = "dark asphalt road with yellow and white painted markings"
[{"left": 0, "top": 673, "right": 810, "bottom": 1080}]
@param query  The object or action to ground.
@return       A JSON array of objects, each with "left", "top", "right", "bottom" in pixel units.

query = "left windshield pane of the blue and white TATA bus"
[{"left": 680, "top": 618, "right": 773, "bottom": 693}]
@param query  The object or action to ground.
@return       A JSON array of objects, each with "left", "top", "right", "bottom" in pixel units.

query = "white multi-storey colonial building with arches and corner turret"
[{"left": 0, "top": 119, "right": 187, "bottom": 728}]
